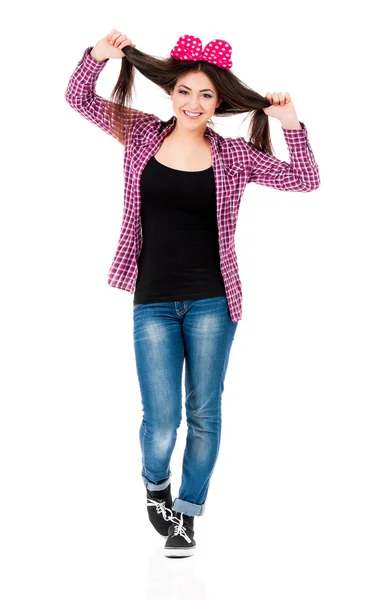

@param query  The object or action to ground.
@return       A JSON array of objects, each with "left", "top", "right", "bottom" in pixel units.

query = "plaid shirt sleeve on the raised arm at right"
[{"left": 242, "top": 121, "right": 321, "bottom": 192}]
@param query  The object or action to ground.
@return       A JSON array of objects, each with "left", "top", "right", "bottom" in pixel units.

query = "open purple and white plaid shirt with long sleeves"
[{"left": 65, "top": 46, "right": 320, "bottom": 322}]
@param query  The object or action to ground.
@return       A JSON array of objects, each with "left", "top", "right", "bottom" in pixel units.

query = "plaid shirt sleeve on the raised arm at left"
[{"left": 65, "top": 46, "right": 155, "bottom": 142}]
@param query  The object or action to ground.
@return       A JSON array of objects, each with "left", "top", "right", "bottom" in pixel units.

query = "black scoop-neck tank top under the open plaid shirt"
[{"left": 134, "top": 156, "right": 226, "bottom": 304}]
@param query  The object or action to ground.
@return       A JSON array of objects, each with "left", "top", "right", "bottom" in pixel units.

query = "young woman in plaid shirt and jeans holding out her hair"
[{"left": 65, "top": 29, "right": 320, "bottom": 557}]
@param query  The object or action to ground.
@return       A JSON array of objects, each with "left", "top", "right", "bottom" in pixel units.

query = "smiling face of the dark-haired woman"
[{"left": 170, "top": 71, "right": 221, "bottom": 130}]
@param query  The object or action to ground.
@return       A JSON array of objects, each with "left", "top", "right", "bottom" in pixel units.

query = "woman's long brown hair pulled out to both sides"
[{"left": 107, "top": 46, "right": 273, "bottom": 154}]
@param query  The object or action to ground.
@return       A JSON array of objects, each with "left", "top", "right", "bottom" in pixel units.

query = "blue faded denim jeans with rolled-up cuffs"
[{"left": 133, "top": 296, "right": 238, "bottom": 516}]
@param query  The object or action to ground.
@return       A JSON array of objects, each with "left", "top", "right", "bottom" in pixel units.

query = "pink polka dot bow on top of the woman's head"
[{"left": 170, "top": 35, "right": 233, "bottom": 69}]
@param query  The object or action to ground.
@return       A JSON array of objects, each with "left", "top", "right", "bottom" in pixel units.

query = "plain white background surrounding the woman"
[{"left": 0, "top": 0, "right": 385, "bottom": 600}]
